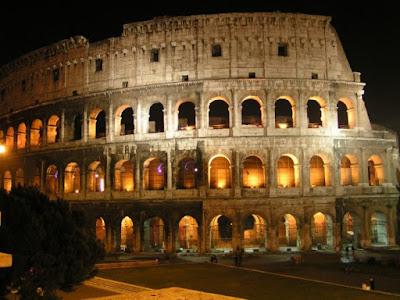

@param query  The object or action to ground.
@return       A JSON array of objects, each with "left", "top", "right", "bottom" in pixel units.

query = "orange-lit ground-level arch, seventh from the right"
[{"left": 179, "top": 216, "right": 199, "bottom": 252}]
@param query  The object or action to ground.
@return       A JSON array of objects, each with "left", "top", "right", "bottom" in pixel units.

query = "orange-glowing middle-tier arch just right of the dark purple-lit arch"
[{"left": 208, "top": 156, "right": 231, "bottom": 189}]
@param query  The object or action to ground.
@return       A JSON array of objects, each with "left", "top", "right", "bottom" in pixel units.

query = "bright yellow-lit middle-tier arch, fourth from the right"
[{"left": 277, "top": 155, "right": 300, "bottom": 188}]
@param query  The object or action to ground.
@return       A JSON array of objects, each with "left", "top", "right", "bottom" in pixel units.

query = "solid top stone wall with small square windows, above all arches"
[{"left": 0, "top": 13, "right": 362, "bottom": 116}]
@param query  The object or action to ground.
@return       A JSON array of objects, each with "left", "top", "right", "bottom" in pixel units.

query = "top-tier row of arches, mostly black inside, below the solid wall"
[{"left": 0, "top": 97, "right": 355, "bottom": 149}]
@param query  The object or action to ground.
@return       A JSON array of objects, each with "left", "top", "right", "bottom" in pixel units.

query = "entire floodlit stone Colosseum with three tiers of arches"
[{"left": 0, "top": 12, "right": 400, "bottom": 253}]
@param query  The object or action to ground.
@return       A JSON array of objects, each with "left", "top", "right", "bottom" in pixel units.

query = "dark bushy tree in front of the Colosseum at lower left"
[{"left": 0, "top": 187, "right": 104, "bottom": 299}]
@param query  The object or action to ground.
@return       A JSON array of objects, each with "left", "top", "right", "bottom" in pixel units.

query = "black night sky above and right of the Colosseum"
[{"left": 0, "top": 0, "right": 400, "bottom": 133}]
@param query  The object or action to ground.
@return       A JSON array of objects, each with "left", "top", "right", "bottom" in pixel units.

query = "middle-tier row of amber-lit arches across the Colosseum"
[{"left": 0, "top": 154, "right": 384, "bottom": 194}]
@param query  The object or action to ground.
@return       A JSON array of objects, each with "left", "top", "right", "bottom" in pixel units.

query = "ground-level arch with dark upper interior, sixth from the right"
[{"left": 210, "top": 215, "right": 232, "bottom": 252}]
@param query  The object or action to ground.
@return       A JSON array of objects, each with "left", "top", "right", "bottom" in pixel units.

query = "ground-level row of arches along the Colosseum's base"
[{"left": 96, "top": 211, "right": 388, "bottom": 252}]
